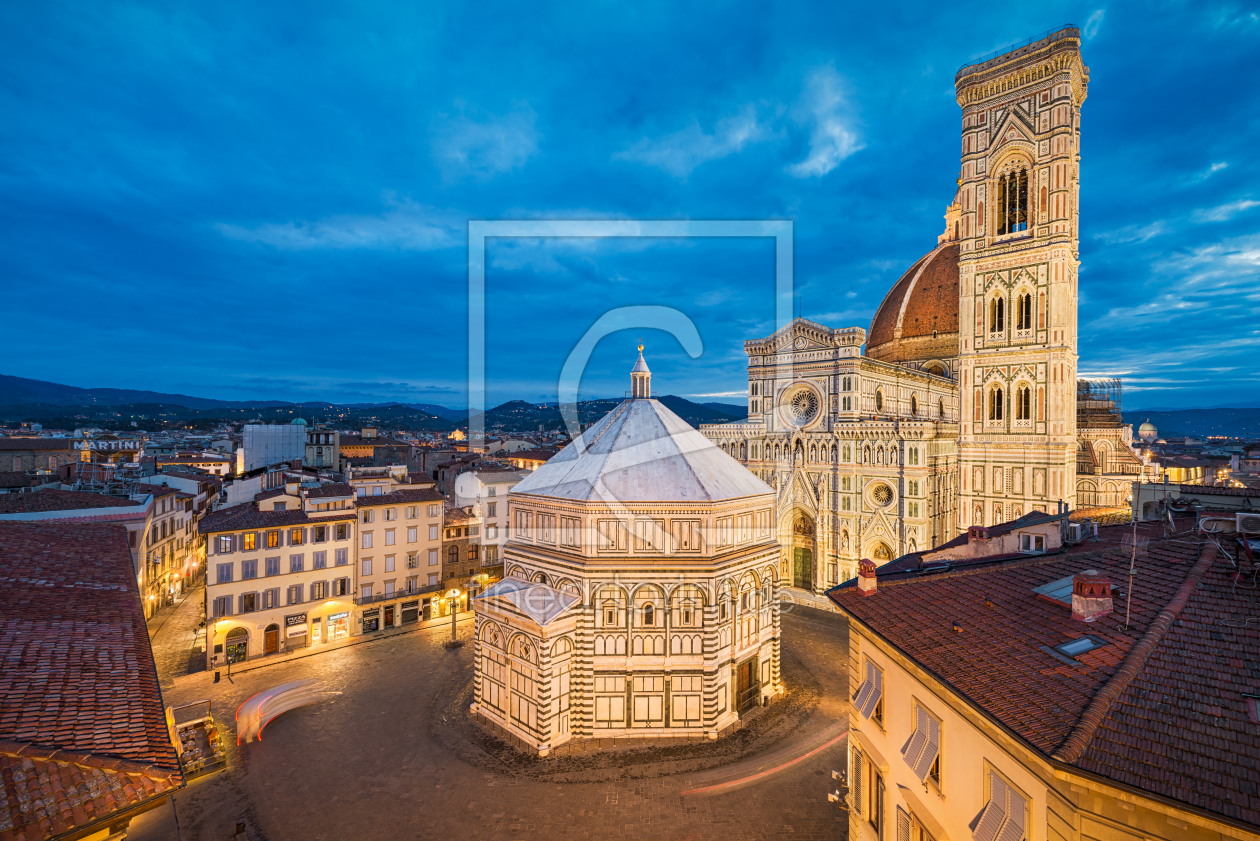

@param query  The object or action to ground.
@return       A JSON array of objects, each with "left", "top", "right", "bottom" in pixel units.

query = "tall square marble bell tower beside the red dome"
[{"left": 955, "top": 26, "right": 1089, "bottom": 527}]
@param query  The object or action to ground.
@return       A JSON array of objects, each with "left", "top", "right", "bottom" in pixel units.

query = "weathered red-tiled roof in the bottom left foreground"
[{"left": 0, "top": 522, "right": 183, "bottom": 841}]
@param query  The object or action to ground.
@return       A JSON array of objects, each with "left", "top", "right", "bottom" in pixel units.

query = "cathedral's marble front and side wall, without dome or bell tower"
[{"left": 701, "top": 319, "right": 958, "bottom": 591}]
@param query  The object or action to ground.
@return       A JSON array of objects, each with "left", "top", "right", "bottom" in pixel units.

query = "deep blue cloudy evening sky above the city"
[{"left": 0, "top": 1, "right": 1260, "bottom": 409}]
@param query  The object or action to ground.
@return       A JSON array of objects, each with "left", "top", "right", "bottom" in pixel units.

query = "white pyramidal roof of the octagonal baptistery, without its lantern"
[{"left": 512, "top": 397, "right": 774, "bottom": 503}]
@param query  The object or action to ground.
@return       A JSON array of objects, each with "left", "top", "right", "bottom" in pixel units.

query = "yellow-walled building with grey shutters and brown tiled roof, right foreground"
[{"left": 829, "top": 526, "right": 1260, "bottom": 841}]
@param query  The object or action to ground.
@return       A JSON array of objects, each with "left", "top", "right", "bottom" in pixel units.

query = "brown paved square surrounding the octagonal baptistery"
[{"left": 129, "top": 609, "right": 848, "bottom": 841}]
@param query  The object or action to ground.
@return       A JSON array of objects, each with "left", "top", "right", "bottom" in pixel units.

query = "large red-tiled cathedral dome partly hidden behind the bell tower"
[{"left": 866, "top": 242, "right": 959, "bottom": 362}]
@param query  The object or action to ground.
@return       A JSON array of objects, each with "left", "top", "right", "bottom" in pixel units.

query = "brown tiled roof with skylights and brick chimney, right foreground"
[{"left": 828, "top": 519, "right": 1260, "bottom": 827}]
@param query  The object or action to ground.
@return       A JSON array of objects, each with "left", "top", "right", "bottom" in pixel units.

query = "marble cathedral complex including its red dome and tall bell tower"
[{"left": 702, "top": 26, "right": 1108, "bottom": 591}]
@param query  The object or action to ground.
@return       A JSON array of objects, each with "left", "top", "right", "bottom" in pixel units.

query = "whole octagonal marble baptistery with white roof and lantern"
[{"left": 473, "top": 356, "right": 782, "bottom": 755}]
